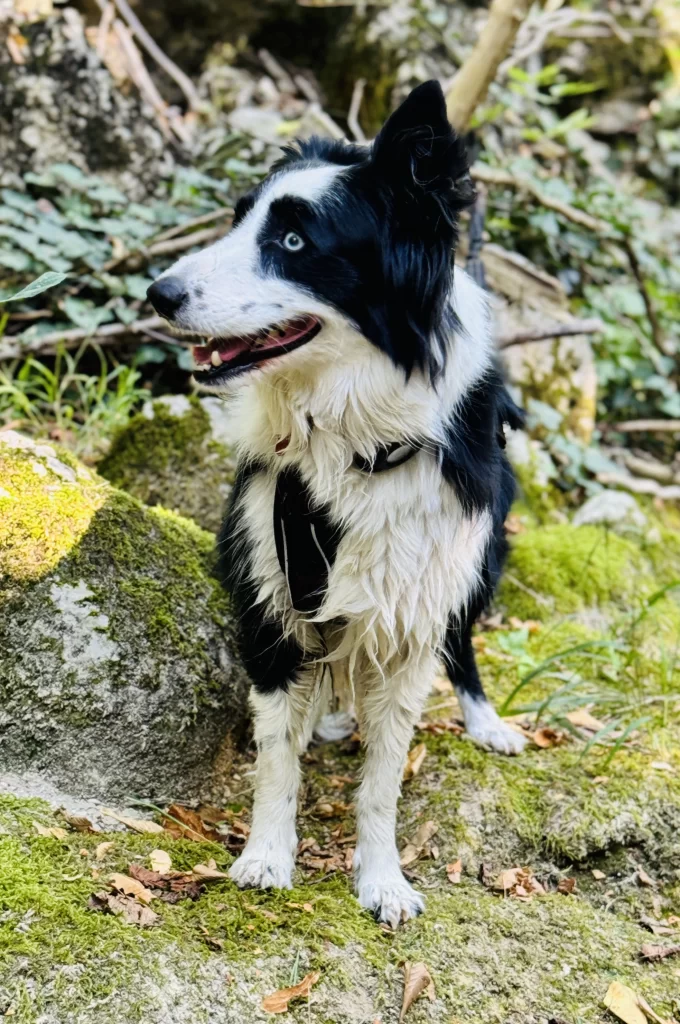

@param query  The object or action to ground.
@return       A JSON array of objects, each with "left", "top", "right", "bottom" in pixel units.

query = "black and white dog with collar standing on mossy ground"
[{"left": 148, "top": 82, "right": 524, "bottom": 926}]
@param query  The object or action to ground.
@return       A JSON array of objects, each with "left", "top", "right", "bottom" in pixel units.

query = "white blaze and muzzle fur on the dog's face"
[{"left": 163, "top": 164, "right": 346, "bottom": 337}]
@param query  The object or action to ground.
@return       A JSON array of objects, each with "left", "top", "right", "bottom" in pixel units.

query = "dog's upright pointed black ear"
[{"left": 373, "top": 80, "right": 474, "bottom": 209}]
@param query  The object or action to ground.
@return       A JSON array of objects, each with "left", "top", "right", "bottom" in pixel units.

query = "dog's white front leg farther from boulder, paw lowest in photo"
[{"left": 354, "top": 662, "right": 434, "bottom": 928}]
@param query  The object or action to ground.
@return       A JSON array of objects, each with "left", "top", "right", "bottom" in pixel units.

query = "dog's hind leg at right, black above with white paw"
[{"left": 443, "top": 623, "right": 526, "bottom": 754}]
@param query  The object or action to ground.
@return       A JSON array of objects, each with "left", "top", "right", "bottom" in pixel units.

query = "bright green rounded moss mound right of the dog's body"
[{"left": 499, "top": 524, "right": 653, "bottom": 618}]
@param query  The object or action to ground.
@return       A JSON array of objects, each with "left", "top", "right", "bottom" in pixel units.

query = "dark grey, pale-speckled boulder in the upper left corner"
[{"left": 0, "top": 7, "right": 174, "bottom": 200}]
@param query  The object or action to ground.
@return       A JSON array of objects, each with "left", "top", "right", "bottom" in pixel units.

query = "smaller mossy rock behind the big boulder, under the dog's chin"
[{"left": 98, "top": 395, "right": 236, "bottom": 532}]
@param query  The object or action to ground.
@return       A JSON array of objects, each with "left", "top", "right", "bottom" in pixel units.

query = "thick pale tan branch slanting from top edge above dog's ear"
[{"left": 447, "top": 0, "right": 532, "bottom": 132}]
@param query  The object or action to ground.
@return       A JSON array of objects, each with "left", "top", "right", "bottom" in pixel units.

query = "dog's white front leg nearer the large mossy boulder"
[{"left": 229, "top": 675, "right": 313, "bottom": 889}]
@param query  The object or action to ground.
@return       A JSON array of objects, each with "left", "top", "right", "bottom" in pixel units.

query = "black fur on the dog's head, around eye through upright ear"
[{"left": 248, "top": 82, "right": 474, "bottom": 377}]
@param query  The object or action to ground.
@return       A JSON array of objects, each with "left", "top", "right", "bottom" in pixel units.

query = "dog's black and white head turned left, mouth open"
[{"left": 144, "top": 82, "right": 473, "bottom": 388}]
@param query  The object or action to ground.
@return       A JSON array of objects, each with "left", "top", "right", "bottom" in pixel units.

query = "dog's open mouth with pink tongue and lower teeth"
[{"left": 192, "top": 315, "right": 322, "bottom": 386}]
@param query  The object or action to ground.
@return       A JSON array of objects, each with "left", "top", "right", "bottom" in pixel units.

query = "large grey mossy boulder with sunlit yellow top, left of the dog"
[{"left": 0, "top": 431, "right": 247, "bottom": 799}]
